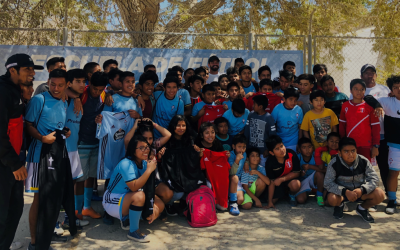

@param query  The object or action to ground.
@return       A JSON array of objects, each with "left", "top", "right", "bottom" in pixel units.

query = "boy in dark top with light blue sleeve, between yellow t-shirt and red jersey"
[{"left": 321, "top": 75, "right": 349, "bottom": 117}]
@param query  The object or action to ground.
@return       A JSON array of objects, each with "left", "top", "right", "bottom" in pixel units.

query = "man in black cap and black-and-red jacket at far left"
[{"left": 0, "top": 54, "right": 43, "bottom": 249}]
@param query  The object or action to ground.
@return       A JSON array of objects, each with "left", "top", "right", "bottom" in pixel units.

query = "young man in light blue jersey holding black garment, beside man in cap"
[{"left": 25, "top": 69, "right": 72, "bottom": 249}]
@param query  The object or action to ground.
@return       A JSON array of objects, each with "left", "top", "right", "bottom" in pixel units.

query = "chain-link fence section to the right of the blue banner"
[{"left": 313, "top": 36, "right": 400, "bottom": 95}]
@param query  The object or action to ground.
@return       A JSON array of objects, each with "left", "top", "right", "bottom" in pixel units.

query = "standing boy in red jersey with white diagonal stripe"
[{"left": 339, "top": 79, "right": 381, "bottom": 161}]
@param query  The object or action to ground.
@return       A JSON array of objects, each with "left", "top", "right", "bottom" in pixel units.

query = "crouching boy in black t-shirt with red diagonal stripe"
[{"left": 265, "top": 135, "right": 301, "bottom": 208}]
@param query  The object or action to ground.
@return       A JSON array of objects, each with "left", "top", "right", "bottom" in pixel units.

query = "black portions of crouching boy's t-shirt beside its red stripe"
[{"left": 265, "top": 148, "right": 301, "bottom": 179}]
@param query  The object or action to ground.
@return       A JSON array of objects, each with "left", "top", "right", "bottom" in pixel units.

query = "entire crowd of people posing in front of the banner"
[{"left": 0, "top": 54, "right": 400, "bottom": 250}]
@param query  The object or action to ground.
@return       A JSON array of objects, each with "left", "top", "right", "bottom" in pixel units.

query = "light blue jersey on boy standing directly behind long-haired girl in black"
[{"left": 153, "top": 91, "right": 184, "bottom": 139}]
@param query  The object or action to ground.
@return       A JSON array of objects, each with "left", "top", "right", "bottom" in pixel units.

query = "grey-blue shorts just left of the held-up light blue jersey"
[{"left": 77, "top": 142, "right": 99, "bottom": 182}]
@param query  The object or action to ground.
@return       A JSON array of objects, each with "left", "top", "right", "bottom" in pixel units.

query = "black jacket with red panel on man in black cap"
[{"left": 0, "top": 76, "right": 24, "bottom": 172}]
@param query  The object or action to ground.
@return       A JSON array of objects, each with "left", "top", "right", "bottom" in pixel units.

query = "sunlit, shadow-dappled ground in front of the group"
[{"left": 11, "top": 166, "right": 400, "bottom": 250}]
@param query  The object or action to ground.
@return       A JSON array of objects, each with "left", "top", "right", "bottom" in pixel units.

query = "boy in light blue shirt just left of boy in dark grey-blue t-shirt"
[{"left": 223, "top": 99, "right": 250, "bottom": 136}]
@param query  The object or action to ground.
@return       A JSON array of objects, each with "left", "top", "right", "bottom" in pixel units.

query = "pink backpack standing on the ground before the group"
[{"left": 184, "top": 185, "right": 218, "bottom": 227}]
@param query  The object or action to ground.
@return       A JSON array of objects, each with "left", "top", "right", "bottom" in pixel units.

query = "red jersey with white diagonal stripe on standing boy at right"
[{"left": 339, "top": 101, "right": 381, "bottom": 147}]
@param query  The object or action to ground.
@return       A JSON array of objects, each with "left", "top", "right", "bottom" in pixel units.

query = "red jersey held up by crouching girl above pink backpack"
[{"left": 200, "top": 149, "right": 231, "bottom": 207}]
